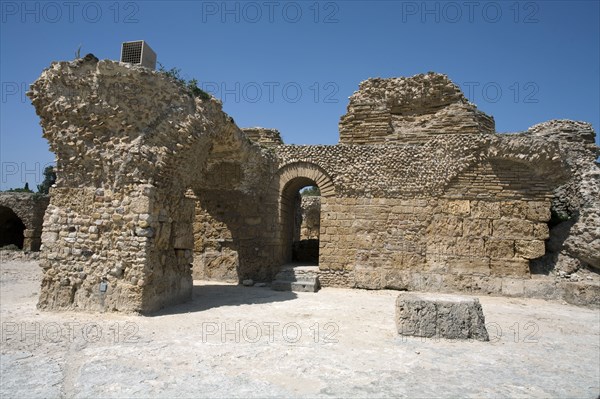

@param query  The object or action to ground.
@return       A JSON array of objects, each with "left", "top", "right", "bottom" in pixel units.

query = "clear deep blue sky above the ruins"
[{"left": 0, "top": 0, "right": 600, "bottom": 189}]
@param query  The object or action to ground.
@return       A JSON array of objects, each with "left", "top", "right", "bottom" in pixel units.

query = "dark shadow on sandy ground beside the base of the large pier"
[{"left": 145, "top": 282, "right": 297, "bottom": 317}]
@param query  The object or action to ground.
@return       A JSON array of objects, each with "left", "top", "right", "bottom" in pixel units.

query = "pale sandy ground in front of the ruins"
[{"left": 0, "top": 261, "right": 600, "bottom": 399}]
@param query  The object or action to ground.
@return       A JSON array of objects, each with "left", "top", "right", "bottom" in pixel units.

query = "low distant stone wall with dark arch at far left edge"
[{"left": 0, "top": 192, "right": 50, "bottom": 251}]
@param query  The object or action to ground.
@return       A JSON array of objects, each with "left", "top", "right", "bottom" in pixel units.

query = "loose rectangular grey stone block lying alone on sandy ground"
[{"left": 396, "top": 293, "right": 489, "bottom": 341}]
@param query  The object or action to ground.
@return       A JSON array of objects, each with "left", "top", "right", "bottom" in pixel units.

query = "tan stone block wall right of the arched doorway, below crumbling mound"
[{"left": 278, "top": 142, "right": 557, "bottom": 293}]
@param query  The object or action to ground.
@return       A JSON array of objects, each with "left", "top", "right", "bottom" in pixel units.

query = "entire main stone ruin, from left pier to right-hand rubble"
[{"left": 23, "top": 55, "right": 600, "bottom": 313}]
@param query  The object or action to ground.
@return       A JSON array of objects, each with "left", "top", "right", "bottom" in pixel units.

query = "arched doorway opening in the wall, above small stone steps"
[{"left": 282, "top": 177, "right": 321, "bottom": 265}]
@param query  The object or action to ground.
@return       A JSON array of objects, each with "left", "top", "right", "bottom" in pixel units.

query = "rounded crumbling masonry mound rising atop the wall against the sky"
[{"left": 340, "top": 73, "right": 495, "bottom": 144}]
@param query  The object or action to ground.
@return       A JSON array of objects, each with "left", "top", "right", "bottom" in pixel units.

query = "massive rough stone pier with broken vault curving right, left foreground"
[{"left": 28, "top": 55, "right": 276, "bottom": 312}]
